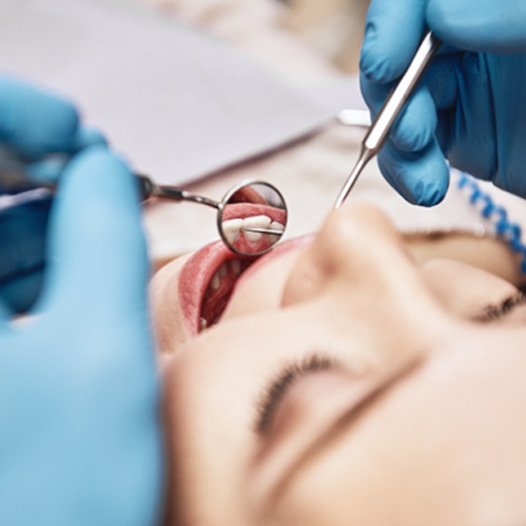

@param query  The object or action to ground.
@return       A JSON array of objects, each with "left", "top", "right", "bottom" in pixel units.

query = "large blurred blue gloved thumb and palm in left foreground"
[{"left": 0, "top": 147, "right": 162, "bottom": 526}]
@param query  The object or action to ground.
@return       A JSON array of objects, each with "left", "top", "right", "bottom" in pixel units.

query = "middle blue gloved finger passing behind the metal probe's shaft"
[{"left": 360, "top": 71, "right": 437, "bottom": 152}]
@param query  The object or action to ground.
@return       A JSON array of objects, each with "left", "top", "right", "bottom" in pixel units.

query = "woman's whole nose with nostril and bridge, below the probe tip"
[{"left": 283, "top": 204, "right": 454, "bottom": 364}]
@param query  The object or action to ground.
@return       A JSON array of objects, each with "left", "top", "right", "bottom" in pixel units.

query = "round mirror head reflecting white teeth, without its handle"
[{"left": 221, "top": 181, "right": 287, "bottom": 256}]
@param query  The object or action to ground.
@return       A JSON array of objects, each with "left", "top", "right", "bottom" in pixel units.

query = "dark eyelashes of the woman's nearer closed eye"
[{"left": 254, "top": 353, "right": 337, "bottom": 435}]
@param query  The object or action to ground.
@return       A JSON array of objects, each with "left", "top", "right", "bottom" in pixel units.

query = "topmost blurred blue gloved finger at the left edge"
[{"left": 0, "top": 76, "right": 79, "bottom": 159}]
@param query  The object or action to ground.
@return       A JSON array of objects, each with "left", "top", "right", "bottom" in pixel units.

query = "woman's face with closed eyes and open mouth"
[{"left": 153, "top": 206, "right": 526, "bottom": 526}]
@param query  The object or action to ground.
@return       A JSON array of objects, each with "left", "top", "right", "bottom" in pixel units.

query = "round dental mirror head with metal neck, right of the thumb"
[{"left": 138, "top": 175, "right": 288, "bottom": 257}]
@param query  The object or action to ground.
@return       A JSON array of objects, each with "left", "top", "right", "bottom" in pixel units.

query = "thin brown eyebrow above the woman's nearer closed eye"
[{"left": 268, "top": 354, "right": 425, "bottom": 505}]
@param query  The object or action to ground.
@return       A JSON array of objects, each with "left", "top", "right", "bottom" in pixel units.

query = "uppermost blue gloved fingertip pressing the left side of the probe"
[{"left": 360, "top": 0, "right": 427, "bottom": 84}]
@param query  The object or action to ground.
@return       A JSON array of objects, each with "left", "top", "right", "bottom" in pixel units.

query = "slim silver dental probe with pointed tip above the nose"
[{"left": 334, "top": 32, "right": 440, "bottom": 209}]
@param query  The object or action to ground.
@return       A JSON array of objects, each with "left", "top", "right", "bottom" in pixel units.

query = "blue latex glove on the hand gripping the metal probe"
[{"left": 360, "top": 0, "right": 526, "bottom": 205}]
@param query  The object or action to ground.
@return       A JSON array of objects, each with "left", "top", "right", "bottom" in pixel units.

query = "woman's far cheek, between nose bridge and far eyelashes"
[{"left": 421, "top": 260, "right": 517, "bottom": 318}]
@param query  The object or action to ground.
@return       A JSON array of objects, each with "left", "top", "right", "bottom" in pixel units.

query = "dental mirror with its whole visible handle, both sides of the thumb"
[{"left": 0, "top": 166, "right": 288, "bottom": 257}]
